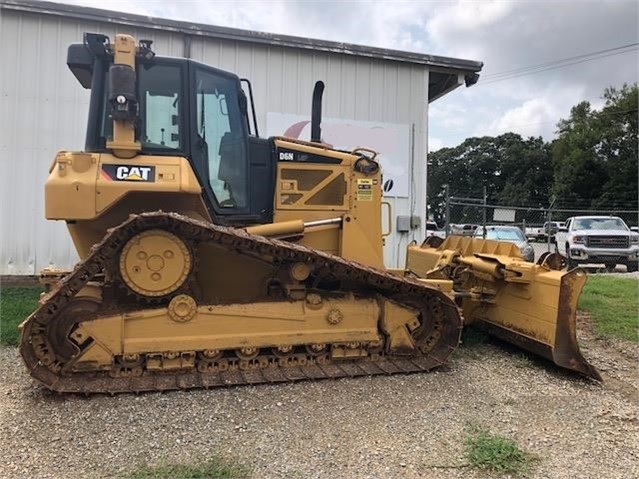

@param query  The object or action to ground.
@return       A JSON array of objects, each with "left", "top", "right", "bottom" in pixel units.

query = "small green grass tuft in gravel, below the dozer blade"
[{"left": 464, "top": 426, "right": 537, "bottom": 476}]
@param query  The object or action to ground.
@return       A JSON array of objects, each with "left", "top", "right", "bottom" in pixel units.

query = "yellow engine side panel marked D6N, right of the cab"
[{"left": 274, "top": 140, "right": 384, "bottom": 268}]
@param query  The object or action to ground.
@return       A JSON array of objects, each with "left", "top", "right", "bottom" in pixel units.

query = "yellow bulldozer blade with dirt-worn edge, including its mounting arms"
[{"left": 407, "top": 236, "right": 601, "bottom": 380}]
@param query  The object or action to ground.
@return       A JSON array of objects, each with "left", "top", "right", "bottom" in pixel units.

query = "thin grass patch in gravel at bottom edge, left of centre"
[{"left": 124, "top": 457, "right": 251, "bottom": 479}]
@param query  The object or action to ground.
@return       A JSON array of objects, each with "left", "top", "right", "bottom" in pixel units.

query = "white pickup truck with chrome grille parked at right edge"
[{"left": 565, "top": 216, "right": 639, "bottom": 271}]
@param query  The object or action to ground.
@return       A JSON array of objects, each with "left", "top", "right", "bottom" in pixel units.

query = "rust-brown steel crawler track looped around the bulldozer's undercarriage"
[{"left": 20, "top": 211, "right": 462, "bottom": 394}]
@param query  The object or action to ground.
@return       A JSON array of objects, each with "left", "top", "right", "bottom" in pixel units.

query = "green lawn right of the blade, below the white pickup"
[{"left": 579, "top": 276, "right": 639, "bottom": 342}]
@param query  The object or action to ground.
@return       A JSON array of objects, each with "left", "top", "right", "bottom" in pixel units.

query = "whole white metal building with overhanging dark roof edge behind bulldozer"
[{"left": 0, "top": 0, "right": 482, "bottom": 275}]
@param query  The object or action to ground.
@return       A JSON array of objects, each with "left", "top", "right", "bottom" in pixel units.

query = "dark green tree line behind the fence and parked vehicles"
[{"left": 428, "top": 83, "right": 639, "bottom": 224}]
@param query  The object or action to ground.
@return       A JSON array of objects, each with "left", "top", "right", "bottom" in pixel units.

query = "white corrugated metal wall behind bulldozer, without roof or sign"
[{"left": 0, "top": 10, "right": 428, "bottom": 275}]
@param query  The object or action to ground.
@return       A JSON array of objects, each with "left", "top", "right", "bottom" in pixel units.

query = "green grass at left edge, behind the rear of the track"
[{"left": 0, "top": 286, "right": 42, "bottom": 346}]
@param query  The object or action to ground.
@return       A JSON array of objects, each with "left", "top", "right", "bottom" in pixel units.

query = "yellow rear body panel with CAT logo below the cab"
[{"left": 45, "top": 152, "right": 210, "bottom": 258}]
